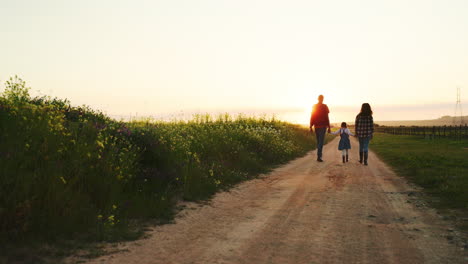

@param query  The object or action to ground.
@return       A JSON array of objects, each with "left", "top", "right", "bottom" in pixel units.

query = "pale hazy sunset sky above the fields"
[{"left": 0, "top": 0, "right": 468, "bottom": 123}]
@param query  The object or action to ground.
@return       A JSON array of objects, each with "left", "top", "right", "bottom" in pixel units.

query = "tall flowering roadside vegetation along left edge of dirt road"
[{"left": 0, "top": 78, "right": 315, "bottom": 262}]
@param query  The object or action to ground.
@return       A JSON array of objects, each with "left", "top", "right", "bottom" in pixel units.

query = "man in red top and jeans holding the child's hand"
[{"left": 310, "top": 95, "right": 330, "bottom": 162}]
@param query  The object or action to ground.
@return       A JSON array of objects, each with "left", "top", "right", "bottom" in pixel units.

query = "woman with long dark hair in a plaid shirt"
[{"left": 355, "top": 103, "right": 374, "bottom": 165}]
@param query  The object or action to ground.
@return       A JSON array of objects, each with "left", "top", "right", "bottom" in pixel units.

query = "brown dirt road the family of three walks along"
[{"left": 82, "top": 139, "right": 468, "bottom": 264}]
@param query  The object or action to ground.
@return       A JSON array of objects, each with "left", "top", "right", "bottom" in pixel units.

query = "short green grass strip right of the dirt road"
[{"left": 370, "top": 133, "right": 468, "bottom": 212}]
